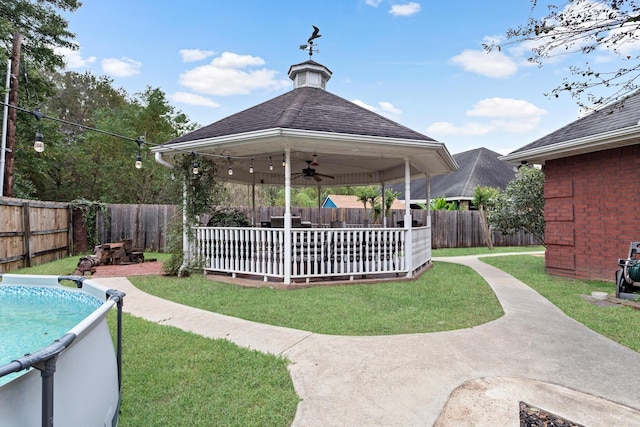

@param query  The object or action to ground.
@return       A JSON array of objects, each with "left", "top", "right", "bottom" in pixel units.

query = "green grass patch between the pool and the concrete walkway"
[{"left": 109, "top": 312, "right": 299, "bottom": 427}]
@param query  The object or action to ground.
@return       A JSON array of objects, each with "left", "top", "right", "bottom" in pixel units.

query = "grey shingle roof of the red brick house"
[{"left": 502, "top": 91, "right": 640, "bottom": 163}]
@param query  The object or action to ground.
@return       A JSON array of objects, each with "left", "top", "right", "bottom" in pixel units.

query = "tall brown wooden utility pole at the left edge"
[{"left": 3, "top": 32, "right": 22, "bottom": 197}]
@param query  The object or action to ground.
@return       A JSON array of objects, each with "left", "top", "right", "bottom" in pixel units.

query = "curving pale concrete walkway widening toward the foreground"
[{"left": 96, "top": 256, "right": 640, "bottom": 427}]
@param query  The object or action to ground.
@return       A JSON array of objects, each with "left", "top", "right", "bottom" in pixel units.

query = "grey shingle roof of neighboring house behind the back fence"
[{"left": 391, "top": 148, "right": 515, "bottom": 201}]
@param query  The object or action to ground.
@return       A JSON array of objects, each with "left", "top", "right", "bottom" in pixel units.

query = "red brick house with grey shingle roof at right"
[{"left": 502, "top": 92, "right": 640, "bottom": 281}]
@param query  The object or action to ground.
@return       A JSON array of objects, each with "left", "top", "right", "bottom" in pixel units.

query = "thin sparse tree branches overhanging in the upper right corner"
[{"left": 485, "top": 0, "right": 640, "bottom": 108}]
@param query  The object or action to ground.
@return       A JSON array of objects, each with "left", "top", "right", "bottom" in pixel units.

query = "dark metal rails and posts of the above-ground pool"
[{"left": 0, "top": 274, "right": 126, "bottom": 427}]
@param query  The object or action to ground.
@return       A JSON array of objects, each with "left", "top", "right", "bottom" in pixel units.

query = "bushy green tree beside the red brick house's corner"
[{"left": 488, "top": 166, "right": 544, "bottom": 245}]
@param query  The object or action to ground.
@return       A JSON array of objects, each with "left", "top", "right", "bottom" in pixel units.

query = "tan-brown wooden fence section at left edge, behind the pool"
[{"left": 0, "top": 197, "right": 73, "bottom": 273}]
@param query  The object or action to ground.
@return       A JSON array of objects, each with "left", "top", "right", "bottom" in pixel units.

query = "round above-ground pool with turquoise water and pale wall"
[{"left": 0, "top": 274, "right": 124, "bottom": 427}]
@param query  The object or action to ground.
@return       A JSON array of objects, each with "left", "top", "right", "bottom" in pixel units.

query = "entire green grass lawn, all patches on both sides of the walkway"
[{"left": 6, "top": 247, "right": 640, "bottom": 427}]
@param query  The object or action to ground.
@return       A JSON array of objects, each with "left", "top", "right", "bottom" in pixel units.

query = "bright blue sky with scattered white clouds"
[{"left": 53, "top": 0, "right": 624, "bottom": 154}]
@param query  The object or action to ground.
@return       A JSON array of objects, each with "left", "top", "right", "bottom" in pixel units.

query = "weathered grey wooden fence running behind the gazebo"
[{"left": 97, "top": 205, "right": 538, "bottom": 252}]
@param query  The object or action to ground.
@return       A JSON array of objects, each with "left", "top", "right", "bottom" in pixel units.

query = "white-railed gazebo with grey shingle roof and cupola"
[{"left": 152, "top": 60, "right": 457, "bottom": 284}]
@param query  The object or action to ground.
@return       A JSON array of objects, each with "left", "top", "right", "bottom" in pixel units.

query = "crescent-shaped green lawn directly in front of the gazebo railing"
[{"left": 129, "top": 263, "right": 503, "bottom": 335}]
